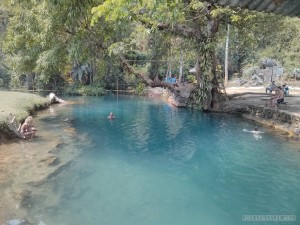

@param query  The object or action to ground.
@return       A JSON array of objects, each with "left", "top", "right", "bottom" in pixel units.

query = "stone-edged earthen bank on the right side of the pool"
[{"left": 216, "top": 87, "right": 300, "bottom": 140}]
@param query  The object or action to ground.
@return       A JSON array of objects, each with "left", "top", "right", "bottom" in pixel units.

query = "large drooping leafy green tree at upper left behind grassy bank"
[{"left": 3, "top": 0, "right": 116, "bottom": 89}]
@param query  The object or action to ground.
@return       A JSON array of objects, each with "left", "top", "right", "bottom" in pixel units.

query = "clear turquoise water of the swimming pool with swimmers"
[{"left": 30, "top": 96, "right": 300, "bottom": 225}]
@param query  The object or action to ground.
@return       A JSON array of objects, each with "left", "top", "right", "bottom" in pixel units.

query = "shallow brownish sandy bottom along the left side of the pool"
[{"left": 0, "top": 105, "right": 85, "bottom": 224}]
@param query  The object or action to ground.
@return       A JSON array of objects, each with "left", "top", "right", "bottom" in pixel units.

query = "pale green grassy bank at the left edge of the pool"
[{"left": 0, "top": 91, "right": 48, "bottom": 138}]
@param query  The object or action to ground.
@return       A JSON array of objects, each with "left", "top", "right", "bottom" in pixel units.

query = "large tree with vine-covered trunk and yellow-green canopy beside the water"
[{"left": 92, "top": 0, "right": 227, "bottom": 109}]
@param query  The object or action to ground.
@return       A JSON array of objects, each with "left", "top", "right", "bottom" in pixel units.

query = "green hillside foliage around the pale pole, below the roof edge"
[{"left": 217, "top": 10, "right": 300, "bottom": 76}]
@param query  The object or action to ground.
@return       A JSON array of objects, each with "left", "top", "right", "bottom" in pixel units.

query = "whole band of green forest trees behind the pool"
[{"left": 0, "top": 0, "right": 300, "bottom": 95}]
